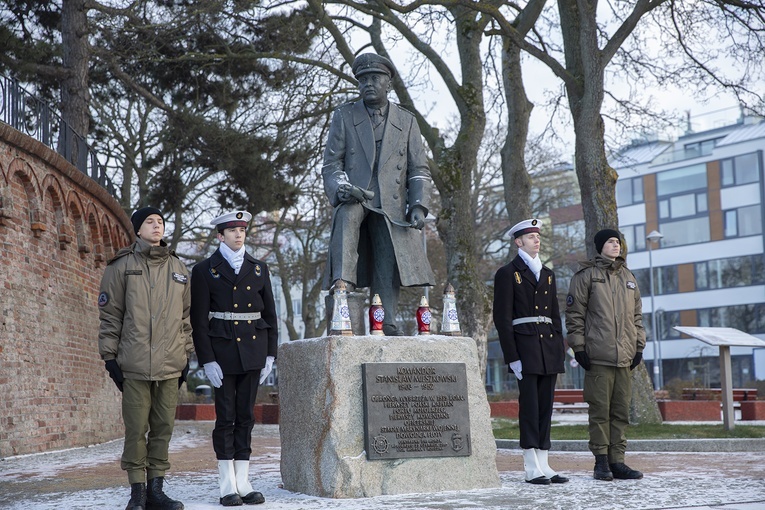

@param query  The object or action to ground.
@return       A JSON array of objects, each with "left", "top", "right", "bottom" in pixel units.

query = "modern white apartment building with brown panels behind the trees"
[{"left": 551, "top": 113, "right": 765, "bottom": 386}]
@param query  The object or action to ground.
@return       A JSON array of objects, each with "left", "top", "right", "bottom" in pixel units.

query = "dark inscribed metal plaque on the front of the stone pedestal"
[{"left": 361, "top": 363, "right": 470, "bottom": 460}]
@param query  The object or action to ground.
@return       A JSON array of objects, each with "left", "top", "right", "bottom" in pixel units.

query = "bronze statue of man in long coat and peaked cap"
[{"left": 321, "top": 53, "right": 435, "bottom": 335}]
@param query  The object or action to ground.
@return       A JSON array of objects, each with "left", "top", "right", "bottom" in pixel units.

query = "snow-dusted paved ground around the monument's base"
[{"left": 0, "top": 421, "right": 765, "bottom": 510}]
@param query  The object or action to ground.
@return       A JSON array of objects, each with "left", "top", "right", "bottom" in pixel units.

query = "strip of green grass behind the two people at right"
[{"left": 492, "top": 418, "right": 765, "bottom": 440}]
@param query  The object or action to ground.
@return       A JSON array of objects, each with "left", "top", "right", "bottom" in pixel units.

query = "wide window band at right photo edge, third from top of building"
[{"left": 694, "top": 255, "right": 765, "bottom": 290}]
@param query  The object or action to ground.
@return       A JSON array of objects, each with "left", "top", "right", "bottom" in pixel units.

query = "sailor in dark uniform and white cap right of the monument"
[{"left": 494, "top": 219, "right": 568, "bottom": 485}]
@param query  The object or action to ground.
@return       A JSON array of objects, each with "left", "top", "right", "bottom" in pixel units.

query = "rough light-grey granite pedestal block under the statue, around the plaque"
[{"left": 278, "top": 335, "right": 500, "bottom": 498}]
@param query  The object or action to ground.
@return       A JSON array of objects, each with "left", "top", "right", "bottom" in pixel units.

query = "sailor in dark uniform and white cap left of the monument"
[{"left": 191, "top": 211, "right": 278, "bottom": 506}]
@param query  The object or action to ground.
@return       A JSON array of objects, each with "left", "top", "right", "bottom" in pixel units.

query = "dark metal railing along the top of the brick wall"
[{"left": 0, "top": 76, "right": 116, "bottom": 196}]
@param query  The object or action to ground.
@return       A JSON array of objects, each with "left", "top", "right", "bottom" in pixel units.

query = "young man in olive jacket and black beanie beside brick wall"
[{"left": 98, "top": 207, "right": 193, "bottom": 510}]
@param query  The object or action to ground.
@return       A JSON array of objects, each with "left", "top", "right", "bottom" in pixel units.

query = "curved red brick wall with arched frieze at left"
[{"left": 0, "top": 123, "right": 132, "bottom": 458}]
